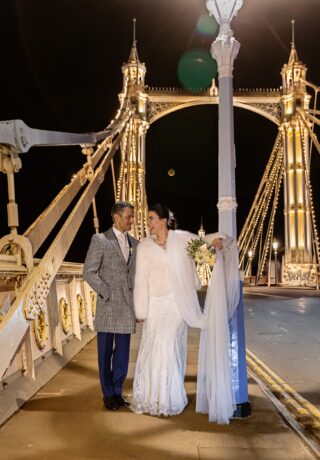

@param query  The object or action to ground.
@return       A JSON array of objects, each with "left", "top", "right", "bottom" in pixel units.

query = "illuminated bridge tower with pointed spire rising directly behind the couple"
[{"left": 116, "top": 19, "right": 149, "bottom": 238}]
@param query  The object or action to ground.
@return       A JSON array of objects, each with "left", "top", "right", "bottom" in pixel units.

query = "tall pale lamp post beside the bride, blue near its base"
[{"left": 206, "top": 0, "right": 250, "bottom": 417}]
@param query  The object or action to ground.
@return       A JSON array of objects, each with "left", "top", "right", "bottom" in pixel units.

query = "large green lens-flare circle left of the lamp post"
[{"left": 178, "top": 49, "right": 217, "bottom": 90}]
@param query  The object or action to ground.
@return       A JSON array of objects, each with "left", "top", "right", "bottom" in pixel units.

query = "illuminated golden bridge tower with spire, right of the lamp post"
[{"left": 280, "top": 29, "right": 316, "bottom": 285}]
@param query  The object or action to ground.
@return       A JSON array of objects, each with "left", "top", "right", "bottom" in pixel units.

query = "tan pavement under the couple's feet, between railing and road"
[{"left": 0, "top": 325, "right": 314, "bottom": 460}]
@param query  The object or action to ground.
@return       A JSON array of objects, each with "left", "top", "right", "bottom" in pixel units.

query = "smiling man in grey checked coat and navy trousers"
[{"left": 83, "top": 201, "right": 139, "bottom": 411}]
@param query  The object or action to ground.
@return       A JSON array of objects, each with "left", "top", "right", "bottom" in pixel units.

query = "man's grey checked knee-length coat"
[{"left": 83, "top": 227, "right": 139, "bottom": 334}]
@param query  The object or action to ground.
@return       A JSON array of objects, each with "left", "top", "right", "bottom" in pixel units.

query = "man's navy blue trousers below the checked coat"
[{"left": 97, "top": 332, "right": 131, "bottom": 397}]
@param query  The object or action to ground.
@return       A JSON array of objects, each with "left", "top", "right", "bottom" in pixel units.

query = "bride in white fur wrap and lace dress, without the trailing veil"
[{"left": 132, "top": 204, "right": 222, "bottom": 416}]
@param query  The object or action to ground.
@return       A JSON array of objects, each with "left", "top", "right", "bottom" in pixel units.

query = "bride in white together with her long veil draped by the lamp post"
[{"left": 132, "top": 204, "right": 239, "bottom": 423}]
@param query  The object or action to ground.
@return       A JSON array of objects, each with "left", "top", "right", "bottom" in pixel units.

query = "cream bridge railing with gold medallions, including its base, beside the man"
[{"left": 0, "top": 260, "right": 100, "bottom": 425}]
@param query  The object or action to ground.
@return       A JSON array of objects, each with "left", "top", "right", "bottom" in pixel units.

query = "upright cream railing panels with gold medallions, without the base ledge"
[{"left": 0, "top": 261, "right": 96, "bottom": 385}]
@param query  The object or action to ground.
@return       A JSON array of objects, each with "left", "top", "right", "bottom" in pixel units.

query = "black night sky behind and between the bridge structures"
[{"left": 0, "top": 0, "right": 320, "bottom": 260}]
